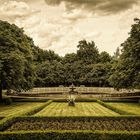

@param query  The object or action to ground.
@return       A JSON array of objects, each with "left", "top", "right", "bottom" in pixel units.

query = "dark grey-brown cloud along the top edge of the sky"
[{"left": 45, "top": 0, "right": 139, "bottom": 14}]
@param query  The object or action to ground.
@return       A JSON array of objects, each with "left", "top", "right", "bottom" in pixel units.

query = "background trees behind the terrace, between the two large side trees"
[{"left": 35, "top": 40, "right": 112, "bottom": 87}]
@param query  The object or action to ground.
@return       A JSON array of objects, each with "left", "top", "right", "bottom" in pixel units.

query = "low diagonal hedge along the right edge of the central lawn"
[{"left": 97, "top": 100, "right": 134, "bottom": 115}]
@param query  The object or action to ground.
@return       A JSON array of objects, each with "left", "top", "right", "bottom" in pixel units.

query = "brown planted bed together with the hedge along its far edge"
[{"left": 5, "top": 117, "right": 140, "bottom": 131}]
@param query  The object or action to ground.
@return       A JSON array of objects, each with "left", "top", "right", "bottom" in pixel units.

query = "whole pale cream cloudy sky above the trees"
[{"left": 0, "top": 0, "right": 140, "bottom": 56}]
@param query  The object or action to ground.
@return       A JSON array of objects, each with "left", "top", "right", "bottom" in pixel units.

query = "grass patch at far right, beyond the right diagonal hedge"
[{"left": 107, "top": 102, "right": 140, "bottom": 115}]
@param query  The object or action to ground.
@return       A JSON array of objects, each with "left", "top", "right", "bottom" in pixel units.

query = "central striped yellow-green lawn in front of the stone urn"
[{"left": 35, "top": 102, "right": 119, "bottom": 116}]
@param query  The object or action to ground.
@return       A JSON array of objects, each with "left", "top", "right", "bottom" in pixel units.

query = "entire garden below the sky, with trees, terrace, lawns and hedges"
[{"left": 0, "top": 19, "right": 140, "bottom": 140}]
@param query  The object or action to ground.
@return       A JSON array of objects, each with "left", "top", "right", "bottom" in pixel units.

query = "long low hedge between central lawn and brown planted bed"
[{"left": 0, "top": 116, "right": 140, "bottom": 131}]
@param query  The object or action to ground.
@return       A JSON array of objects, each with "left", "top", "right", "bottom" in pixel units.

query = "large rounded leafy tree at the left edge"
[{"left": 0, "top": 21, "right": 34, "bottom": 100}]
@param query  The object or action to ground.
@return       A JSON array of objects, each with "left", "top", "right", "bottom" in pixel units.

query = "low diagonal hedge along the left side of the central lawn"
[{"left": 0, "top": 100, "right": 52, "bottom": 131}]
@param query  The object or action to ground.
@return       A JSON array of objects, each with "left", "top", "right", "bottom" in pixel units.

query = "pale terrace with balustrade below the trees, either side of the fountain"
[{"left": 8, "top": 87, "right": 140, "bottom": 101}]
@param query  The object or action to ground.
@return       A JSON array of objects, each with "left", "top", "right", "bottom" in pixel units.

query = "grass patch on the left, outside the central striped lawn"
[{"left": 0, "top": 102, "right": 44, "bottom": 117}]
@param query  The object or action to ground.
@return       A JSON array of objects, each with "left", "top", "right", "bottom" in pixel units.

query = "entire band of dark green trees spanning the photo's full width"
[{"left": 0, "top": 19, "right": 140, "bottom": 100}]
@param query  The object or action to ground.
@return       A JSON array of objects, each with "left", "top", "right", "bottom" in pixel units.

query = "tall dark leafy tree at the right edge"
[{"left": 109, "top": 19, "right": 140, "bottom": 89}]
